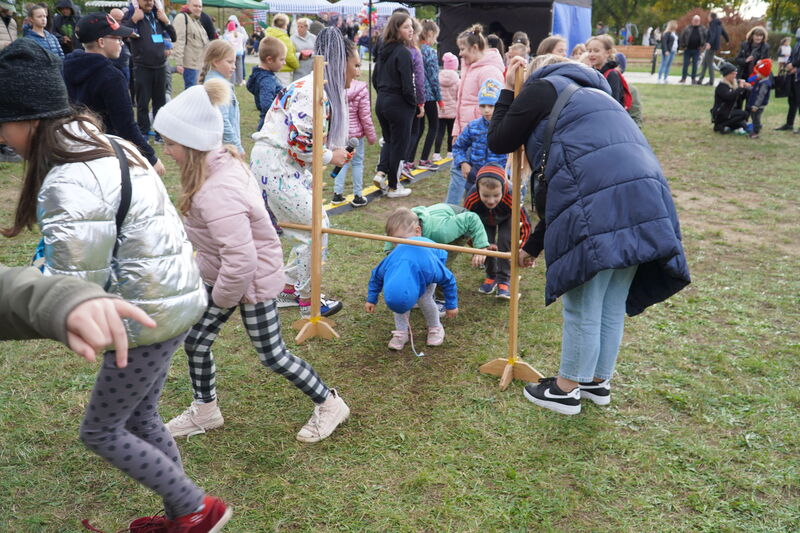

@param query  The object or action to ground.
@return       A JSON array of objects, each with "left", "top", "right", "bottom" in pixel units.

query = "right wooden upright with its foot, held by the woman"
[{"left": 480, "top": 69, "right": 544, "bottom": 390}]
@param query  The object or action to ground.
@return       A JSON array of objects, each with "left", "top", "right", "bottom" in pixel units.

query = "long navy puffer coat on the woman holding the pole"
[{"left": 526, "top": 63, "right": 691, "bottom": 316}]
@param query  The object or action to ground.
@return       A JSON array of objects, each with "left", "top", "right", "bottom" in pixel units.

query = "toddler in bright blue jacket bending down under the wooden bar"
[{"left": 364, "top": 208, "right": 458, "bottom": 350}]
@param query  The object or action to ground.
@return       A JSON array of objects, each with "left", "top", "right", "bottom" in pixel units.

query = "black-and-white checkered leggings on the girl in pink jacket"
[{"left": 184, "top": 289, "right": 329, "bottom": 404}]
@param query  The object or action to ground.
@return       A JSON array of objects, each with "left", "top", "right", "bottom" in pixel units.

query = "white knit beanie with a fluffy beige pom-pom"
[{"left": 153, "top": 79, "right": 231, "bottom": 152}]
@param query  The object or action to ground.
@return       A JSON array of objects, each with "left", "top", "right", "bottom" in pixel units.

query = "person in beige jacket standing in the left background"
[{"left": 172, "top": 0, "right": 208, "bottom": 89}]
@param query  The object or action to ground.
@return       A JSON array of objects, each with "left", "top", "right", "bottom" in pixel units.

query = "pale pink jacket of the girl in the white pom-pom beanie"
[{"left": 184, "top": 148, "right": 284, "bottom": 308}]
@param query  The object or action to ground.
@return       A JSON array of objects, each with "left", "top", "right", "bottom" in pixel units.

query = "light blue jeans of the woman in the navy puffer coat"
[{"left": 558, "top": 265, "right": 637, "bottom": 382}]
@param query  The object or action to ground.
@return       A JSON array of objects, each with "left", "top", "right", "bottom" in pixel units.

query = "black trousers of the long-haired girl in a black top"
[{"left": 375, "top": 93, "right": 417, "bottom": 189}]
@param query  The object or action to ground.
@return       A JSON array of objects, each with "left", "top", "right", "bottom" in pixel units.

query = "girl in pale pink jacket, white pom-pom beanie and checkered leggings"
[{"left": 153, "top": 80, "right": 350, "bottom": 442}]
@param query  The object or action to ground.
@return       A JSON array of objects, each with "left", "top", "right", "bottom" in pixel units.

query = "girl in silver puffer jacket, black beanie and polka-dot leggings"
[{"left": 0, "top": 39, "right": 231, "bottom": 533}]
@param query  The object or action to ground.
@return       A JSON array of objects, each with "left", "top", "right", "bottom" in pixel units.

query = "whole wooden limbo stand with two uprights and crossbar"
[{"left": 280, "top": 56, "right": 543, "bottom": 390}]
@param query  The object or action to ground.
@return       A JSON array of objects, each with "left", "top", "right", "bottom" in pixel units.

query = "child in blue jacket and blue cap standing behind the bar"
[{"left": 445, "top": 78, "right": 508, "bottom": 205}]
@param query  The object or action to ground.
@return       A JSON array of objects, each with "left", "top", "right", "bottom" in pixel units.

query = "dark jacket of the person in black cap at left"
[{"left": 64, "top": 50, "right": 158, "bottom": 164}]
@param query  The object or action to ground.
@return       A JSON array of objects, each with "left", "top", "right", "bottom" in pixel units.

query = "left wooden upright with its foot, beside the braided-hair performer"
[{"left": 292, "top": 56, "right": 339, "bottom": 344}]
